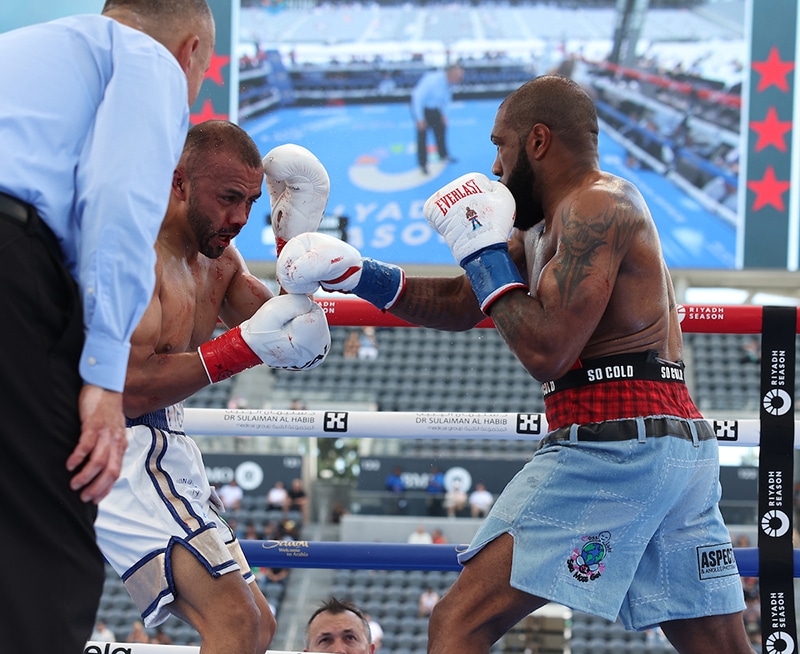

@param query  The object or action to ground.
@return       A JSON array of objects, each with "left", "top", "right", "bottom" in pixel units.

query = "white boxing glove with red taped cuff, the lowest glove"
[{"left": 198, "top": 295, "right": 331, "bottom": 383}]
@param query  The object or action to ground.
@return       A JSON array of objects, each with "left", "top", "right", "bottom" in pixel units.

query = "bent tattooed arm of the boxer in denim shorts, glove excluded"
[{"left": 491, "top": 182, "right": 648, "bottom": 381}]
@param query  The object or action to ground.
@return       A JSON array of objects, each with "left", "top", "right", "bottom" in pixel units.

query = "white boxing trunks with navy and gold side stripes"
[{"left": 95, "top": 405, "right": 255, "bottom": 627}]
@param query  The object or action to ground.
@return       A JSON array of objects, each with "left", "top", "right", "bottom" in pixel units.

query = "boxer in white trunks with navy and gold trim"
[{"left": 96, "top": 121, "right": 330, "bottom": 654}]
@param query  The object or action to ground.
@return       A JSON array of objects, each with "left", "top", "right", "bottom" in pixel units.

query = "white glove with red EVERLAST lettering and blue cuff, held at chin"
[{"left": 422, "top": 173, "right": 528, "bottom": 314}]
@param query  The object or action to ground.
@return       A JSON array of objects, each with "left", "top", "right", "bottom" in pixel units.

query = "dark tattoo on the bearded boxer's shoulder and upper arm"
[{"left": 553, "top": 196, "right": 639, "bottom": 306}]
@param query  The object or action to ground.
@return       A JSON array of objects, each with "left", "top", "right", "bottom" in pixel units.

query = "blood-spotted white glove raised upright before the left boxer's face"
[{"left": 261, "top": 143, "right": 331, "bottom": 254}]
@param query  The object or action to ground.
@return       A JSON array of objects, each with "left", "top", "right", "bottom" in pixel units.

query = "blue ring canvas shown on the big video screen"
[{"left": 236, "top": 99, "right": 736, "bottom": 269}]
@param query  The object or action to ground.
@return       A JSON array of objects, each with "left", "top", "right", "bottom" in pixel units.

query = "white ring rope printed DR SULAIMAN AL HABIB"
[{"left": 184, "top": 408, "right": 772, "bottom": 448}]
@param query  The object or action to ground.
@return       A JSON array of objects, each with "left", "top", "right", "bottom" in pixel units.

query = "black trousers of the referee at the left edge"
[{"left": 0, "top": 195, "right": 104, "bottom": 654}]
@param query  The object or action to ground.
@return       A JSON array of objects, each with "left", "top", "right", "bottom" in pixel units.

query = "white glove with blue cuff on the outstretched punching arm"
[{"left": 276, "top": 232, "right": 406, "bottom": 311}]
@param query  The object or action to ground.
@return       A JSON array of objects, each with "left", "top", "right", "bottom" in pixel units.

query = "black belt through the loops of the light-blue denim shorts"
[{"left": 539, "top": 417, "right": 716, "bottom": 447}]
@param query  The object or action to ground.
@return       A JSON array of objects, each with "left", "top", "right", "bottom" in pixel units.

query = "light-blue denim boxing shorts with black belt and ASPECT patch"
[{"left": 459, "top": 417, "right": 744, "bottom": 630}]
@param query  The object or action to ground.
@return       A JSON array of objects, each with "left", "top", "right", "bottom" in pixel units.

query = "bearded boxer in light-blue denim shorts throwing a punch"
[{"left": 278, "top": 76, "right": 752, "bottom": 654}]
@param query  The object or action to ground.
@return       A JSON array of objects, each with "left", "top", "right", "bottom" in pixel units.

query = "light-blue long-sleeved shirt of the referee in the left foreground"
[{"left": 0, "top": 15, "right": 189, "bottom": 391}]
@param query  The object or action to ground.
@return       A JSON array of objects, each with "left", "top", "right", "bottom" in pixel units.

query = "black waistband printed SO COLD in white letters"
[{"left": 542, "top": 350, "right": 684, "bottom": 397}]
